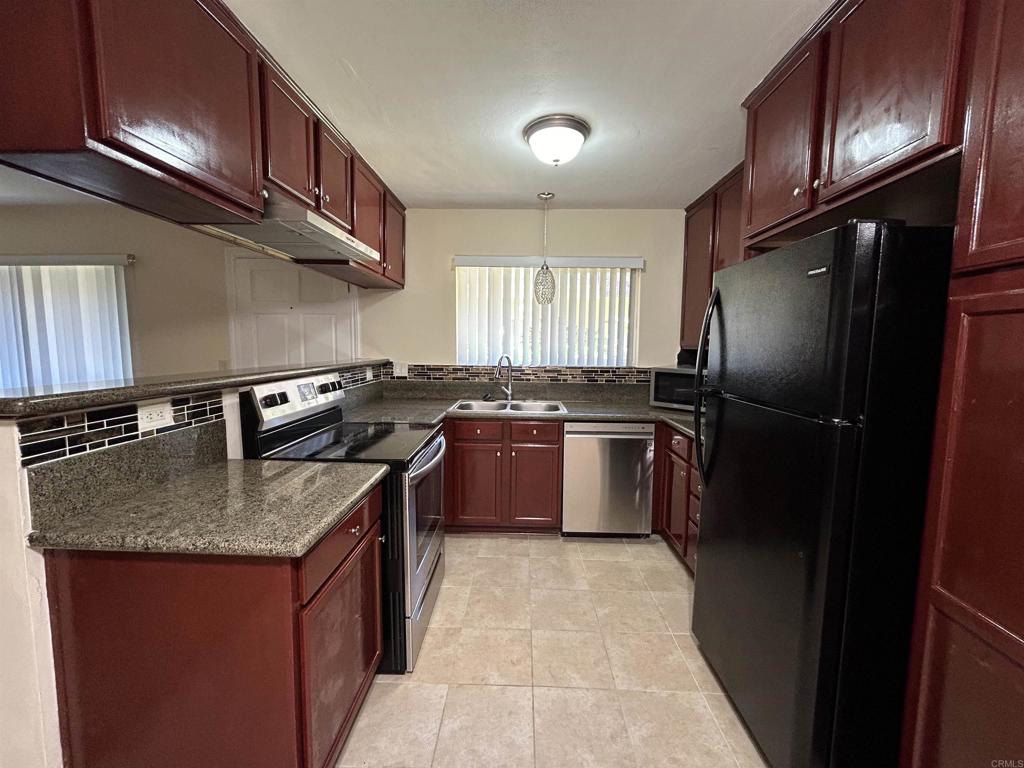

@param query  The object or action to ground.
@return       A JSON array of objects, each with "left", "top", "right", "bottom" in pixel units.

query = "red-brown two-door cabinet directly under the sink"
[{"left": 445, "top": 419, "right": 562, "bottom": 529}]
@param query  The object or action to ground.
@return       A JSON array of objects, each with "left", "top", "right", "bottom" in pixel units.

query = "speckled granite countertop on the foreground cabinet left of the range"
[{"left": 29, "top": 460, "right": 388, "bottom": 557}]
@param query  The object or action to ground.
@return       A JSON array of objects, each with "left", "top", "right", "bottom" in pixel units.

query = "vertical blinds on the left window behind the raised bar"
[{"left": 0, "top": 264, "right": 132, "bottom": 388}]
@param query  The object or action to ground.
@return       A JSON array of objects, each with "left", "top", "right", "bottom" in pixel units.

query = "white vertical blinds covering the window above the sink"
[{"left": 455, "top": 257, "right": 643, "bottom": 366}]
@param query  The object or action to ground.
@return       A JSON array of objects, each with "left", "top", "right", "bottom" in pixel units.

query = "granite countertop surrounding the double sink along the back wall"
[{"left": 345, "top": 397, "right": 693, "bottom": 437}]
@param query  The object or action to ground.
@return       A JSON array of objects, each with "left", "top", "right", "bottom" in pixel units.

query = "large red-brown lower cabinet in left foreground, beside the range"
[{"left": 45, "top": 488, "right": 382, "bottom": 768}]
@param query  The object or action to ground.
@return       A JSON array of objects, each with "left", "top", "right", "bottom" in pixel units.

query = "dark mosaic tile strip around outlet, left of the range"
[{"left": 17, "top": 391, "right": 224, "bottom": 467}]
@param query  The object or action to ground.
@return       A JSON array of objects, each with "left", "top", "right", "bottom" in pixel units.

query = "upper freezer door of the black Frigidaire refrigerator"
[{"left": 708, "top": 222, "right": 885, "bottom": 420}]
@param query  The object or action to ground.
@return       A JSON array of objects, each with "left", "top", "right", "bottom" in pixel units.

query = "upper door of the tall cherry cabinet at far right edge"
[{"left": 953, "top": 0, "right": 1024, "bottom": 271}]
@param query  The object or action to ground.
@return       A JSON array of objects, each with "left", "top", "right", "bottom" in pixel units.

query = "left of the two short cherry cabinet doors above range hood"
[{"left": 260, "top": 61, "right": 316, "bottom": 207}]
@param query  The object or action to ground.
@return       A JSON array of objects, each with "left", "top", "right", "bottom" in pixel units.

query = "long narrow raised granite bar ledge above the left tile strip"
[{"left": 0, "top": 358, "right": 388, "bottom": 418}]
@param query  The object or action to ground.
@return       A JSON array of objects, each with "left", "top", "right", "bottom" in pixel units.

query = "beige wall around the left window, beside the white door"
[{"left": 0, "top": 204, "right": 230, "bottom": 376}]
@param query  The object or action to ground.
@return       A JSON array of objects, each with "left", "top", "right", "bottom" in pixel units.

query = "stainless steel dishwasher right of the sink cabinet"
[{"left": 562, "top": 422, "right": 654, "bottom": 535}]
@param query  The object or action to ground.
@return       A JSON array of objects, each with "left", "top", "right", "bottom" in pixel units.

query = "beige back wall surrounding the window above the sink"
[{"left": 360, "top": 209, "right": 683, "bottom": 366}]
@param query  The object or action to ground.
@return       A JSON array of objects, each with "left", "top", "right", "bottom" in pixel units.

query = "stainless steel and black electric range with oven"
[{"left": 240, "top": 374, "right": 445, "bottom": 674}]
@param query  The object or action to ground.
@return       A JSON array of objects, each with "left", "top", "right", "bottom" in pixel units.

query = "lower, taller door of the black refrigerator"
[{"left": 693, "top": 395, "right": 858, "bottom": 768}]
